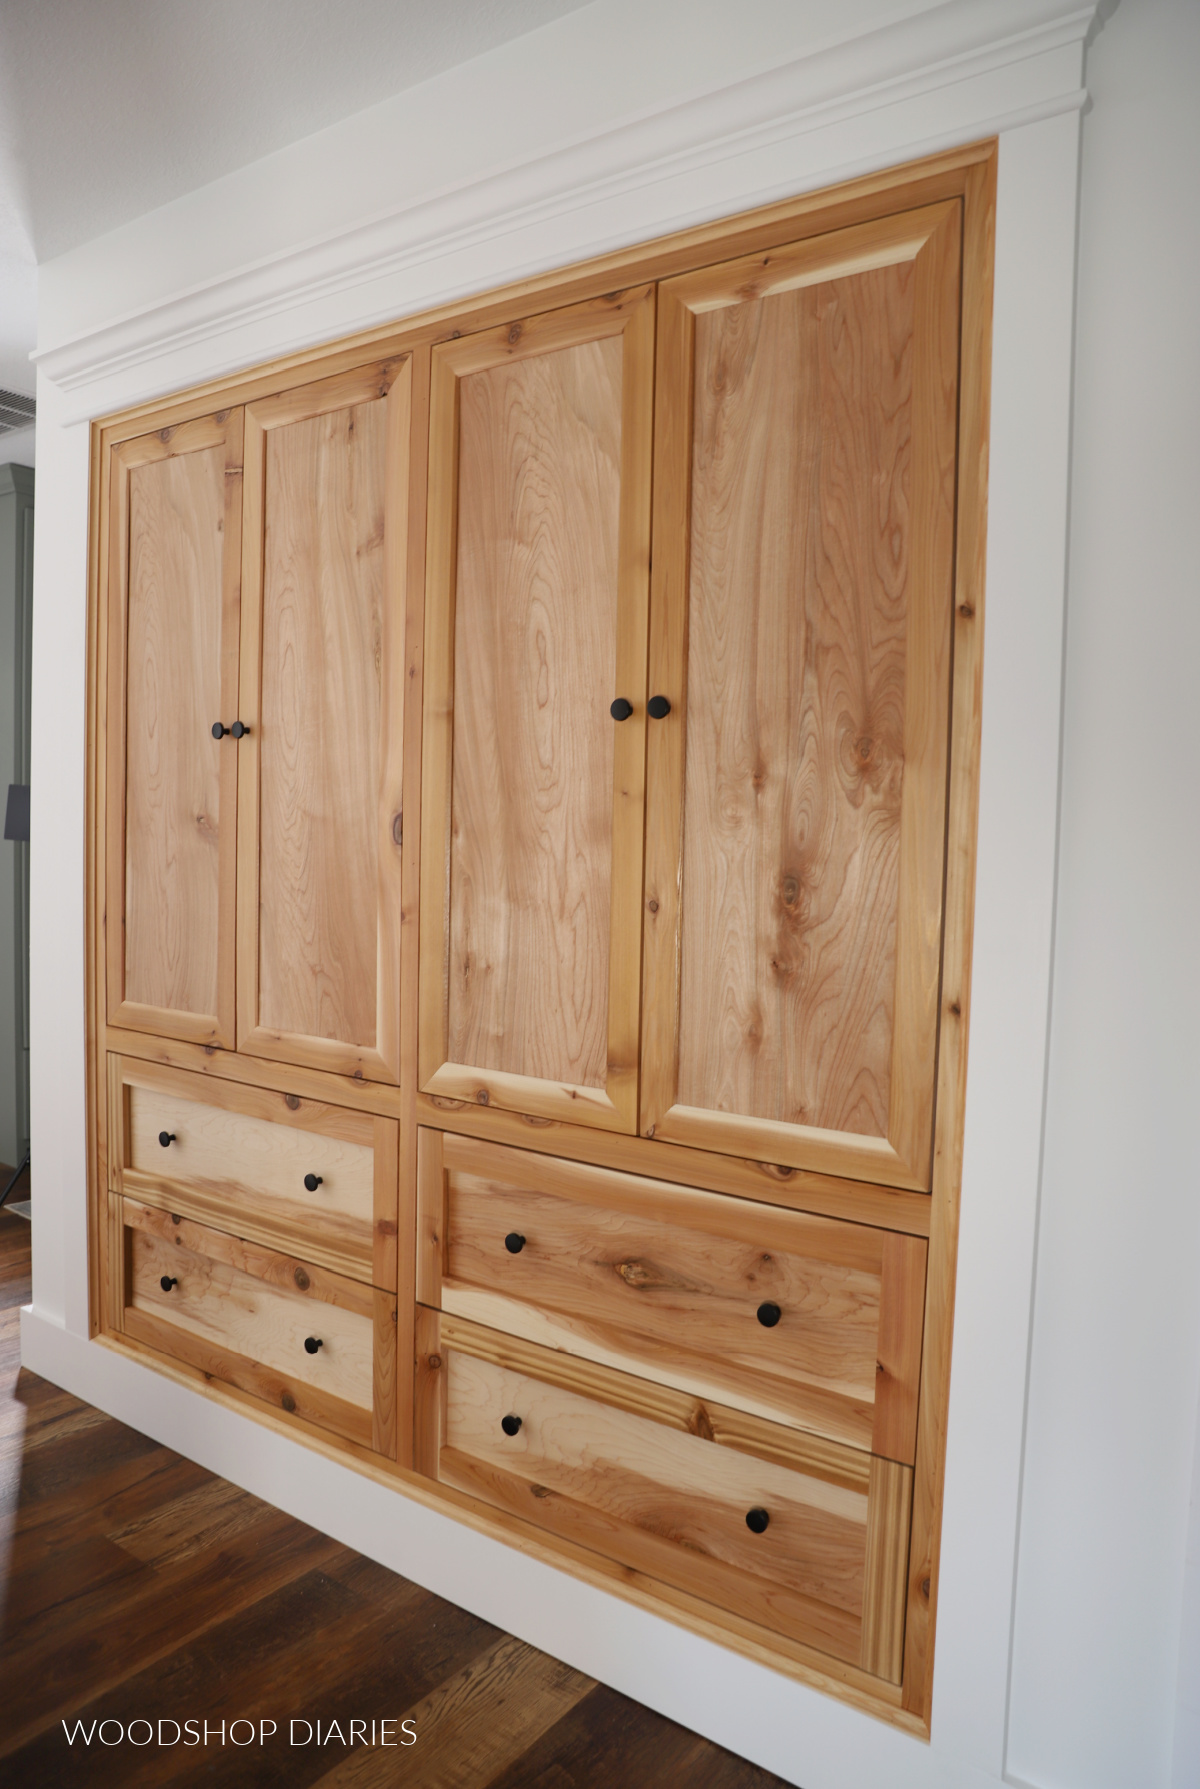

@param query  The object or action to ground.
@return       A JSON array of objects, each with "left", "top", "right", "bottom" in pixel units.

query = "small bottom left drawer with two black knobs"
[{"left": 122, "top": 1199, "right": 395, "bottom": 1458}]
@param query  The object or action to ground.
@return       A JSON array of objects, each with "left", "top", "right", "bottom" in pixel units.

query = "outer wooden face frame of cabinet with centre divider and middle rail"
[{"left": 86, "top": 140, "right": 998, "bottom": 1739}]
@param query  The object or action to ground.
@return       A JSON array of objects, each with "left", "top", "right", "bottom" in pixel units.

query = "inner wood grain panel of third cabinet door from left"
[{"left": 447, "top": 336, "right": 622, "bottom": 1088}]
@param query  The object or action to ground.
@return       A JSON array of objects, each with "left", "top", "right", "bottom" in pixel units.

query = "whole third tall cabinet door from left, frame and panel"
[{"left": 420, "top": 286, "right": 655, "bottom": 1131}]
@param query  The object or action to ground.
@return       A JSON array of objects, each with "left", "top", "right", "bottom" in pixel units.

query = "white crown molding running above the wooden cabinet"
[{"left": 30, "top": 0, "right": 1096, "bottom": 409}]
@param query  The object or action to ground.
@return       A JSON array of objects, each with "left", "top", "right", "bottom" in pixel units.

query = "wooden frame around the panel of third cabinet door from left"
[{"left": 418, "top": 286, "right": 655, "bottom": 1131}]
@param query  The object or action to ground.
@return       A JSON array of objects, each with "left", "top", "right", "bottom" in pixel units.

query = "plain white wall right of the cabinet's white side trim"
[{"left": 1009, "top": 0, "right": 1200, "bottom": 1789}]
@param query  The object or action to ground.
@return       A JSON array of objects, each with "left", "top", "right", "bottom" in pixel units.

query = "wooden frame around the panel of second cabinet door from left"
[{"left": 238, "top": 356, "right": 411, "bottom": 1082}]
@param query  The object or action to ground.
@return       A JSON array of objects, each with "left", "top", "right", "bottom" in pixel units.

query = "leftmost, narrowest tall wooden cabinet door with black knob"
[{"left": 104, "top": 410, "right": 243, "bottom": 1048}]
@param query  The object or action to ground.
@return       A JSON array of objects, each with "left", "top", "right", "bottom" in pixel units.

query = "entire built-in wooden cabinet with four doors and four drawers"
[{"left": 89, "top": 145, "right": 994, "bottom": 1734}]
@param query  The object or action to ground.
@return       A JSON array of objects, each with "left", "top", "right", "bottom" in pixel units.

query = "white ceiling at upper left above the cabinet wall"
[{"left": 0, "top": 0, "right": 587, "bottom": 407}]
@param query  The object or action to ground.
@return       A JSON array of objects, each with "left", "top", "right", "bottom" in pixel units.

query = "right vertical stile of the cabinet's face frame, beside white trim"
[{"left": 903, "top": 152, "right": 996, "bottom": 1726}]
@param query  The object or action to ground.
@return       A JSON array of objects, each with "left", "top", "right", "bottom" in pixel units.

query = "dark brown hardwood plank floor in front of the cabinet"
[{"left": 0, "top": 1211, "right": 794, "bottom": 1789}]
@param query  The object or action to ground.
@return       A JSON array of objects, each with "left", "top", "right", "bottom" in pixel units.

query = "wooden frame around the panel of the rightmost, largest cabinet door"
[{"left": 640, "top": 200, "right": 960, "bottom": 1191}]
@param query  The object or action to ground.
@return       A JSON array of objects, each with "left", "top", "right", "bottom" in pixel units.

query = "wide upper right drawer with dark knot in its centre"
[{"left": 417, "top": 1131, "right": 926, "bottom": 1465}]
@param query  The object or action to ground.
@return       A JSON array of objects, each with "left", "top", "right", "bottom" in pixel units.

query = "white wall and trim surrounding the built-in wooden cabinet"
[{"left": 23, "top": 0, "right": 1200, "bottom": 1789}]
